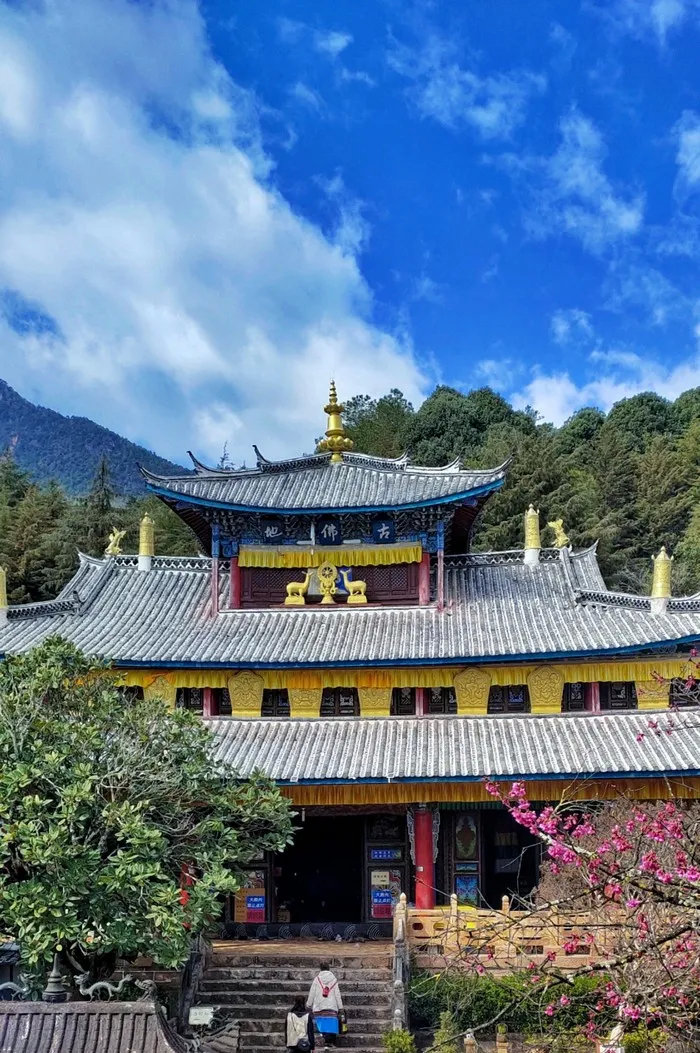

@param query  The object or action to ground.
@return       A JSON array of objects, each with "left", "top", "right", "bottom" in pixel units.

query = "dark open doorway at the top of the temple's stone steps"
[{"left": 274, "top": 816, "right": 364, "bottom": 925}]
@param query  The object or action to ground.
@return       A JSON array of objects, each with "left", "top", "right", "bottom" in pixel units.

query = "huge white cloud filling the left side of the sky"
[{"left": 0, "top": 0, "right": 425, "bottom": 460}]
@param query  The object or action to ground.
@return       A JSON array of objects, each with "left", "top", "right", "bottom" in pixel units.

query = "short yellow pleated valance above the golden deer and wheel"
[{"left": 238, "top": 542, "right": 423, "bottom": 569}]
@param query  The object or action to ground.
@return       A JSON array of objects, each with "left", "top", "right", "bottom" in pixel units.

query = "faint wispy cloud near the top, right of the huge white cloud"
[{"left": 387, "top": 33, "right": 546, "bottom": 139}]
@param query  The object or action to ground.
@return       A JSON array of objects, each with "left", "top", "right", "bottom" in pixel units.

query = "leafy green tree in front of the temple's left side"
[{"left": 0, "top": 638, "right": 292, "bottom": 976}]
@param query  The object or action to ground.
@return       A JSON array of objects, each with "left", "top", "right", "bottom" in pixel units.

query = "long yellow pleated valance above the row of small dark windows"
[{"left": 124, "top": 658, "right": 687, "bottom": 690}]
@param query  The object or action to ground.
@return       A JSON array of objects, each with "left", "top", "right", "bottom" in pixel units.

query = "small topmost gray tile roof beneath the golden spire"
[{"left": 142, "top": 454, "right": 506, "bottom": 512}]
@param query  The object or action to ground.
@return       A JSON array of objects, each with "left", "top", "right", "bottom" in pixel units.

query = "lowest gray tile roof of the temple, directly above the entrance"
[{"left": 208, "top": 713, "right": 700, "bottom": 783}]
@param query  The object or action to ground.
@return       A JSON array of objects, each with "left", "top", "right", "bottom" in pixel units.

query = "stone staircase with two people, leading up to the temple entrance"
[{"left": 197, "top": 943, "right": 393, "bottom": 1053}]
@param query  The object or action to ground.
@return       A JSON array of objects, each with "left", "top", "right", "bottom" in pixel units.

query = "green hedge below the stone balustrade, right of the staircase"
[{"left": 408, "top": 971, "right": 610, "bottom": 1036}]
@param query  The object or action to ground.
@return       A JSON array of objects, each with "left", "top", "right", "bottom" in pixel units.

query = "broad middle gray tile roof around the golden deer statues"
[{"left": 0, "top": 550, "right": 700, "bottom": 668}]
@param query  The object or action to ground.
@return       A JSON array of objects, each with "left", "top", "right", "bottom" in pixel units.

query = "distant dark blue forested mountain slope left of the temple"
[{"left": 0, "top": 380, "right": 181, "bottom": 494}]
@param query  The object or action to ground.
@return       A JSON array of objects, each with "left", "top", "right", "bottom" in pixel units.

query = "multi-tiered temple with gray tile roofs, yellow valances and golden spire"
[{"left": 0, "top": 385, "right": 700, "bottom": 936}]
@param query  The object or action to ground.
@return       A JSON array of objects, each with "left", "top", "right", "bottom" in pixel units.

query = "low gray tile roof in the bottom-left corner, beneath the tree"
[{"left": 0, "top": 1001, "right": 185, "bottom": 1053}]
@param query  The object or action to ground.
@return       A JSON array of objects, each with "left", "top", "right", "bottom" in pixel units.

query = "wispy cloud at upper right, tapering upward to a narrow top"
[{"left": 513, "top": 111, "right": 644, "bottom": 254}]
